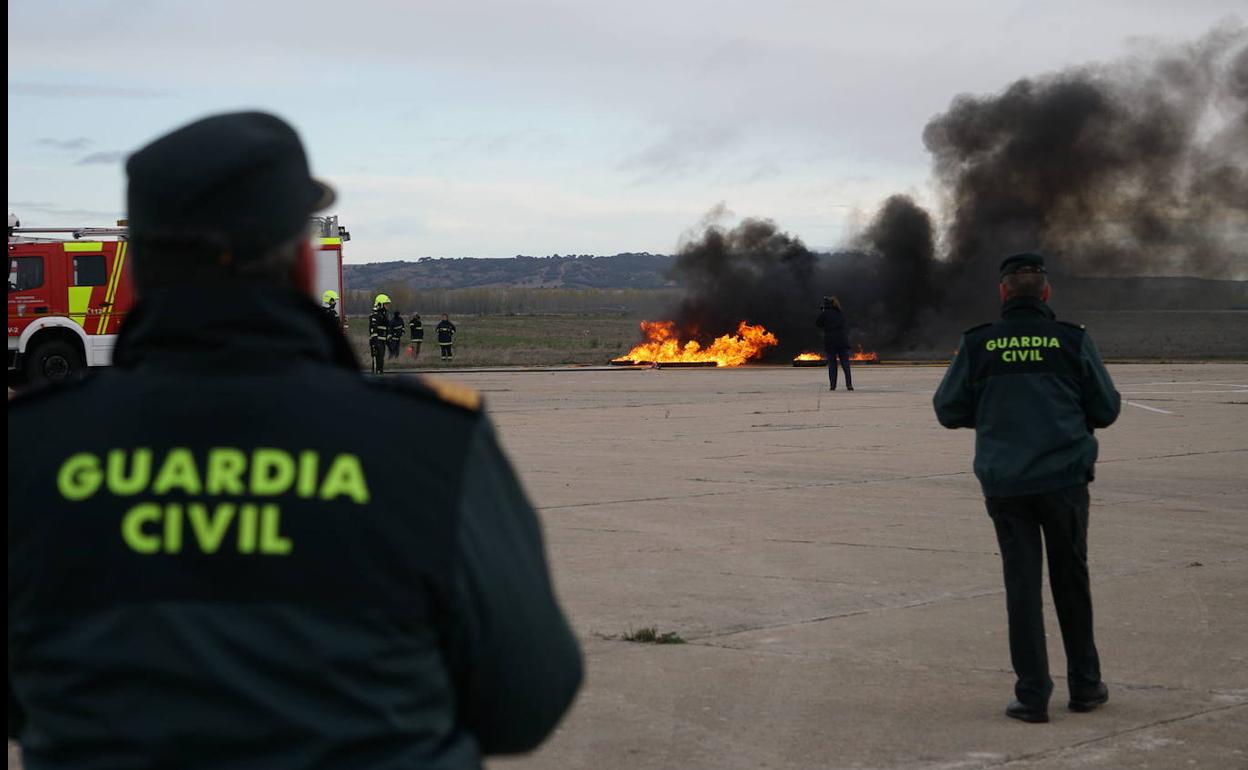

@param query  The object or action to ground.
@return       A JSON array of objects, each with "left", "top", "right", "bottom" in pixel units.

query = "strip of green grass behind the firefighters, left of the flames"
[{"left": 347, "top": 313, "right": 641, "bottom": 369}]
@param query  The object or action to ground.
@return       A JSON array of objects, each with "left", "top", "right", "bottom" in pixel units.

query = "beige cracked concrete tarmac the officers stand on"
[{"left": 10, "top": 363, "right": 1248, "bottom": 770}]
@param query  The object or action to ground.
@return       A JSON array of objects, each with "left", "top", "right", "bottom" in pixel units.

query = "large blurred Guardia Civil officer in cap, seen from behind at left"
[{"left": 9, "top": 114, "right": 582, "bottom": 770}]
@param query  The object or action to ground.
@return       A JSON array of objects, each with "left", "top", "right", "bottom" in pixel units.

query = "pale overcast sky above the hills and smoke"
[{"left": 9, "top": 0, "right": 1248, "bottom": 262}]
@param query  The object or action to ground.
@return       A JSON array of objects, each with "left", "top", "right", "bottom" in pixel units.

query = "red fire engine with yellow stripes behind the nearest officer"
[{"left": 9, "top": 215, "right": 351, "bottom": 382}]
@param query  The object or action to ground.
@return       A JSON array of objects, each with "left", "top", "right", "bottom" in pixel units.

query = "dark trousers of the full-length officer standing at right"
[{"left": 985, "top": 484, "right": 1101, "bottom": 706}]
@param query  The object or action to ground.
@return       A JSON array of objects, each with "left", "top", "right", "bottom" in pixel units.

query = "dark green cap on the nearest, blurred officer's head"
[{"left": 126, "top": 112, "right": 334, "bottom": 251}]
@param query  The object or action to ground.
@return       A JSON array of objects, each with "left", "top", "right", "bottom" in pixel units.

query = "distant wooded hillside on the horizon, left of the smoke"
[{"left": 343, "top": 253, "right": 674, "bottom": 290}]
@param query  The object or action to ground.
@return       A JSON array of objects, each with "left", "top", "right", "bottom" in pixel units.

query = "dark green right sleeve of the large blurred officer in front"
[{"left": 457, "top": 418, "right": 582, "bottom": 754}]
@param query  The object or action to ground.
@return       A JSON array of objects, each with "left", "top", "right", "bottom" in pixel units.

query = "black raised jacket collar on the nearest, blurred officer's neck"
[{"left": 112, "top": 285, "right": 359, "bottom": 372}]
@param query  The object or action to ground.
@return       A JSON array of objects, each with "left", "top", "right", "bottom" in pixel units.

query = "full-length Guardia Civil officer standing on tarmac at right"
[{"left": 935, "top": 253, "right": 1119, "bottom": 721}]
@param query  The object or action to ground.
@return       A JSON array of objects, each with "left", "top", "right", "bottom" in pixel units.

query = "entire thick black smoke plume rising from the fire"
[{"left": 675, "top": 25, "right": 1248, "bottom": 357}]
